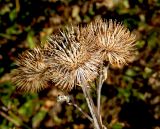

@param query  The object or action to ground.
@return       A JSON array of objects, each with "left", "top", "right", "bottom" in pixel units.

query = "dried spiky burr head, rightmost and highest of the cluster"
[{"left": 90, "top": 19, "right": 136, "bottom": 67}]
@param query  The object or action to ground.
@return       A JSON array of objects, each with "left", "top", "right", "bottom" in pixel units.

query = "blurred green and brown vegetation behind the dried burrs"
[{"left": 0, "top": 0, "right": 160, "bottom": 129}]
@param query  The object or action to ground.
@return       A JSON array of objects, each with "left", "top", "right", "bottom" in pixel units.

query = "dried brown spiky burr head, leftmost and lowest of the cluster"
[{"left": 12, "top": 47, "right": 52, "bottom": 92}]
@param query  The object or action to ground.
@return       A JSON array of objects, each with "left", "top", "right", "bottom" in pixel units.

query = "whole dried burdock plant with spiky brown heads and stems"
[{"left": 12, "top": 19, "right": 136, "bottom": 129}]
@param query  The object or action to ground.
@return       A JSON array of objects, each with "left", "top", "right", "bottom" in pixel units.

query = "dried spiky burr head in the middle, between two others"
[{"left": 49, "top": 32, "right": 101, "bottom": 90}]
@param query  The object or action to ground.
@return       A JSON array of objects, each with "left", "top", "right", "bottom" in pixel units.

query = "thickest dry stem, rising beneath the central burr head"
[{"left": 82, "top": 84, "right": 102, "bottom": 129}]
